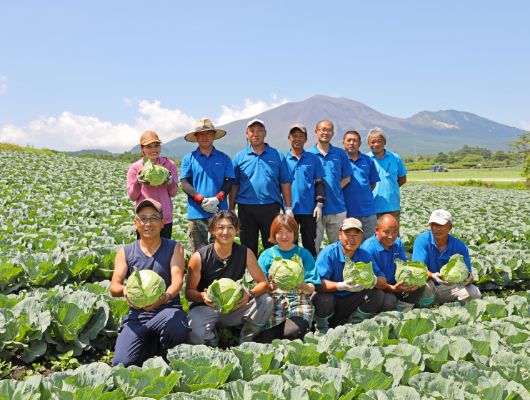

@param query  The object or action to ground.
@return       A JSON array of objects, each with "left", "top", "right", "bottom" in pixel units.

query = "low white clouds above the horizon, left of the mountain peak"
[{"left": 0, "top": 96, "right": 287, "bottom": 152}]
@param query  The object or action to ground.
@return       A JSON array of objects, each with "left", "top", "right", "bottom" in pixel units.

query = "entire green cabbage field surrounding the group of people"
[{"left": 0, "top": 151, "right": 530, "bottom": 400}]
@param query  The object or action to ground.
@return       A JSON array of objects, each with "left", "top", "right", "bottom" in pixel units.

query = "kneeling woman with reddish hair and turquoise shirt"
[{"left": 256, "top": 214, "right": 320, "bottom": 343}]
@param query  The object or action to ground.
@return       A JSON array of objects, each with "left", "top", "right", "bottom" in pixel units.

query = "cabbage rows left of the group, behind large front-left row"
[{"left": 0, "top": 151, "right": 186, "bottom": 293}]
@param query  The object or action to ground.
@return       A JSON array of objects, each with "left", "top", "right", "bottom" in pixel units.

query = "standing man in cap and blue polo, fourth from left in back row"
[{"left": 285, "top": 124, "right": 326, "bottom": 257}]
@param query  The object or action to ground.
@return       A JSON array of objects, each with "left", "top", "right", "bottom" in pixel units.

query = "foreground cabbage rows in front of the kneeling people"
[{"left": 0, "top": 292, "right": 530, "bottom": 400}]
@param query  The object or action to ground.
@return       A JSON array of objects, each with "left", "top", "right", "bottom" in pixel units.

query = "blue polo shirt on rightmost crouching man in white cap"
[{"left": 412, "top": 231, "right": 471, "bottom": 272}]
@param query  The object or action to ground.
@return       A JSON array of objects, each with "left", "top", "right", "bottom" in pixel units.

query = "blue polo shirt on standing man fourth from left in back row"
[{"left": 285, "top": 150, "right": 324, "bottom": 215}]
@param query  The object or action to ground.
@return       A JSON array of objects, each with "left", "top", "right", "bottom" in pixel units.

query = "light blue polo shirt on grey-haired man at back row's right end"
[{"left": 368, "top": 150, "right": 407, "bottom": 213}]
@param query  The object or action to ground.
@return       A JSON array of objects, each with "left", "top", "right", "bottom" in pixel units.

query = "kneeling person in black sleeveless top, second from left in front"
[{"left": 186, "top": 211, "right": 273, "bottom": 346}]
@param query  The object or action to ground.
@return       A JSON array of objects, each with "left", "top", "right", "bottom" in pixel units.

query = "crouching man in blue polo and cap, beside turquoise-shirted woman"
[{"left": 312, "top": 218, "right": 386, "bottom": 333}]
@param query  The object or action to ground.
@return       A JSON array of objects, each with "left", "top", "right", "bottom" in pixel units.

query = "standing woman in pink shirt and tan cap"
[{"left": 127, "top": 131, "right": 178, "bottom": 239}]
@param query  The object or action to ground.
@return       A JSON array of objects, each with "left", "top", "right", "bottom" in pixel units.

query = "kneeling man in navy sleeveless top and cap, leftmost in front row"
[{"left": 109, "top": 199, "right": 189, "bottom": 366}]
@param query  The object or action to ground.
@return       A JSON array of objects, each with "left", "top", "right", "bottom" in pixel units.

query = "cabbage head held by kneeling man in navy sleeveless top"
[{"left": 127, "top": 269, "right": 166, "bottom": 308}]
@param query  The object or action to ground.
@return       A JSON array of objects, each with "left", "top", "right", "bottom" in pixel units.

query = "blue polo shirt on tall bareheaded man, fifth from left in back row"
[{"left": 308, "top": 145, "right": 353, "bottom": 215}]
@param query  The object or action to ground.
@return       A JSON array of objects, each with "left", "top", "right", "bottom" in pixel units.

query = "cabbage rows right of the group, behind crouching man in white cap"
[{"left": 400, "top": 185, "right": 530, "bottom": 289}]
